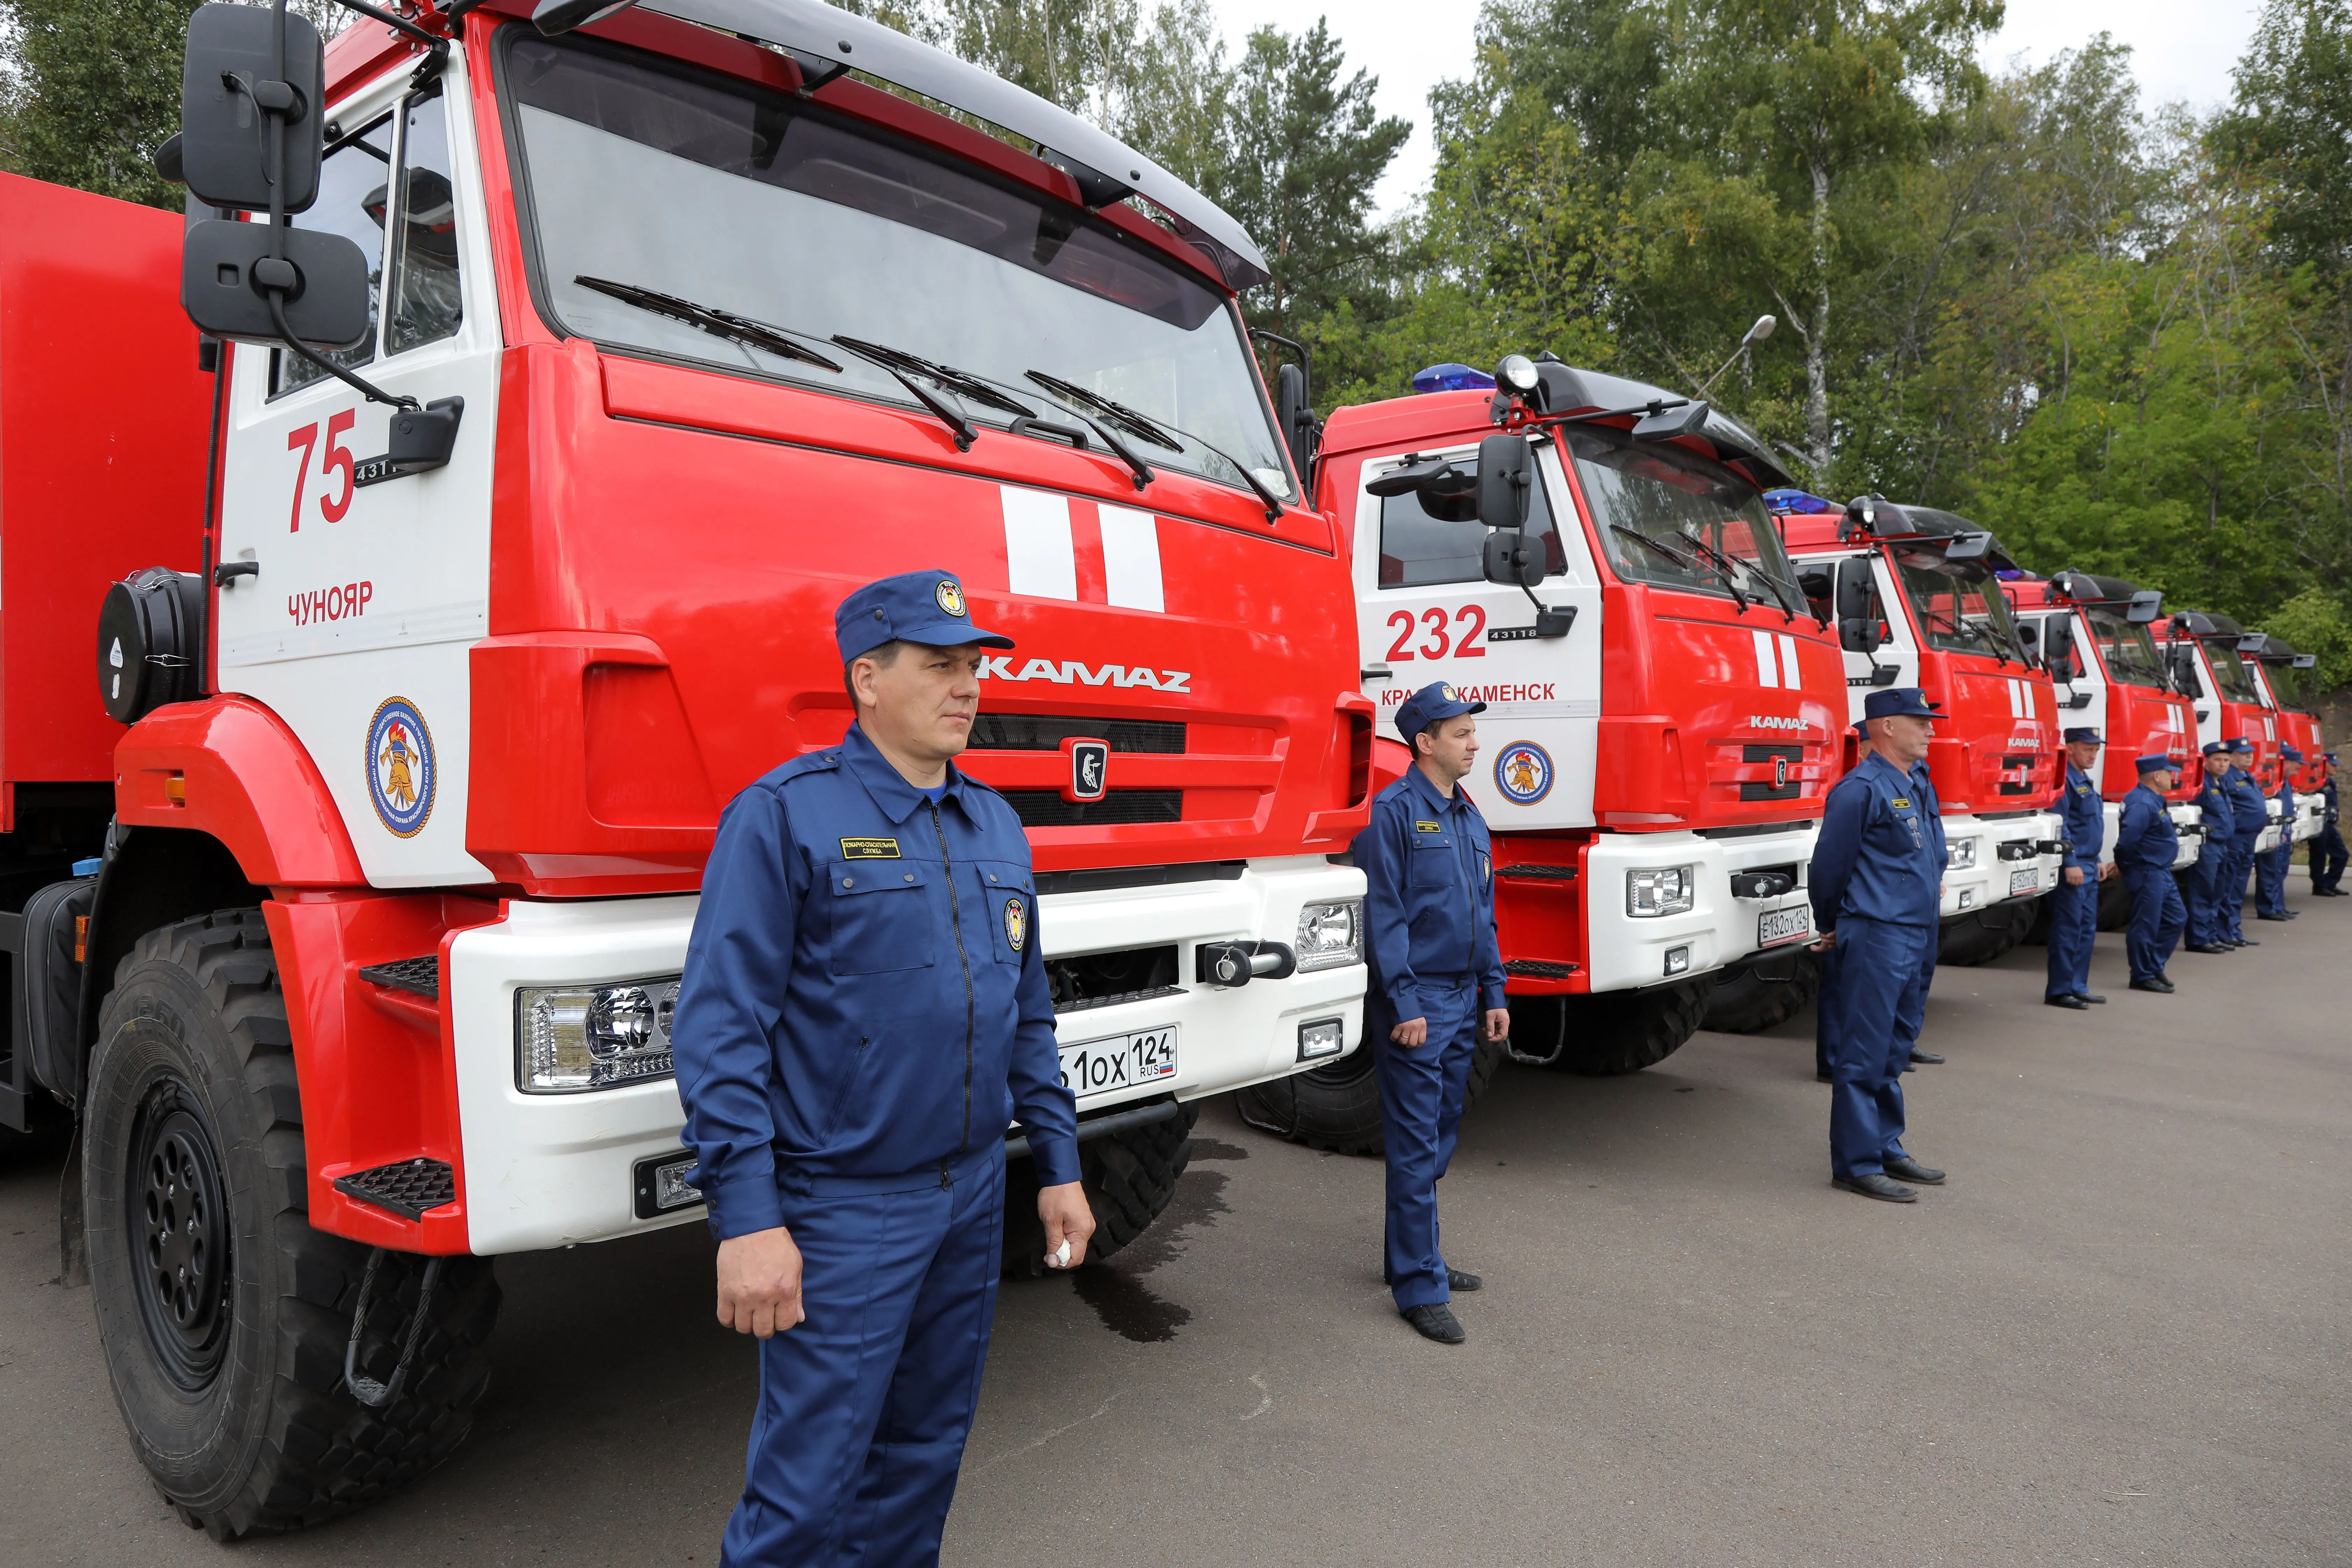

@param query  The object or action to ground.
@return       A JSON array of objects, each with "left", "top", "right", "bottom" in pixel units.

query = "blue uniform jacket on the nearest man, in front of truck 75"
[{"left": 670, "top": 726, "right": 1077, "bottom": 1239}]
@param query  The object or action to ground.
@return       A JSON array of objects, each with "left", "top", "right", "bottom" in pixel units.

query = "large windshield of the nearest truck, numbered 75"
[{"left": 506, "top": 28, "right": 1294, "bottom": 498}]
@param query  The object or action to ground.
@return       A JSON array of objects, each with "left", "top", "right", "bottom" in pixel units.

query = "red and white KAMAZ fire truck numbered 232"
[{"left": 1242, "top": 355, "right": 1844, "bottom": 1149}]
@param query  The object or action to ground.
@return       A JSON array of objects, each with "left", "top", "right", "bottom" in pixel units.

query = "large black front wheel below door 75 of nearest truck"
[{"left": 82, "top": 910, "right": 499, "bottom": 1540}]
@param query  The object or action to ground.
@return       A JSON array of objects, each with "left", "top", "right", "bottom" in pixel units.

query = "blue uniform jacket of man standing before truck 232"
[{"left": 1355, "top": 766, "right": 1503, "bottom": 1023}]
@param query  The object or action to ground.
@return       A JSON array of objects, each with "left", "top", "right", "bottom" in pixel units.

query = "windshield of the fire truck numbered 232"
[{"left": 1562, "top": 426, "right": 1802, "bottom": 604}]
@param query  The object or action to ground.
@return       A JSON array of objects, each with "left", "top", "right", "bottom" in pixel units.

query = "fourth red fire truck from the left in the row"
[{"left": 2009, "top": 571, "right": 2204, "bottom": 929}]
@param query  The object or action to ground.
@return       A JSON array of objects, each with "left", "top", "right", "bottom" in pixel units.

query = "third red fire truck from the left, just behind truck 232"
[{"left": 1773, "top": 493, "right": 2065, "bottom": 964}]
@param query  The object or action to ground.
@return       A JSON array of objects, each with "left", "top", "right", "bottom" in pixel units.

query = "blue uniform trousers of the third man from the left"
[{"left": 1820, "top": 915, "right": 1936, "bottom": 1175}]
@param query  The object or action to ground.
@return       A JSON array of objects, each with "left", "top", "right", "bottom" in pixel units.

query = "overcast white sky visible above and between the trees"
[{"left": 1211, "top": 0, "right": 2260, "bottom": 214}]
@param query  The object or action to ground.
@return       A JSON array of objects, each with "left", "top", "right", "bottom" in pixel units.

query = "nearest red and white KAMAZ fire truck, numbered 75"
[{"left": 0, "top": 0, "right": 1376, "bottom": 1538}]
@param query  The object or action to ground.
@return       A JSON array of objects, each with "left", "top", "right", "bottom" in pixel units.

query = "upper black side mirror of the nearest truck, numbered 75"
[{"left": 179, "top": 5, "right": 327, "bottom": 211}]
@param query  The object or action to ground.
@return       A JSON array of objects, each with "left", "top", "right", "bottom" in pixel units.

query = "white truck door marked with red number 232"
[{"left": 1355, "top": 442, "right": 1602, "bottom": 832}]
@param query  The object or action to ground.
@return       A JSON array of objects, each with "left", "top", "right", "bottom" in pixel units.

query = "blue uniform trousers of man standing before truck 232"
[{"left": 1364, "top": 975, "right": 1479, "bottom": 1312}]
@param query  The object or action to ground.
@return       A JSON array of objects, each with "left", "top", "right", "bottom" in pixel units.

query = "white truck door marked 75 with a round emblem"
[{"left": 216, "top": 56, "right": 499, "bottom": 886}]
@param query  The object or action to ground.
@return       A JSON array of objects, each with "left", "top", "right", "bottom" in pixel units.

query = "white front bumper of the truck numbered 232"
[{"left": 1585, "top": 823, "right": 1818, "bottom": 992}]
